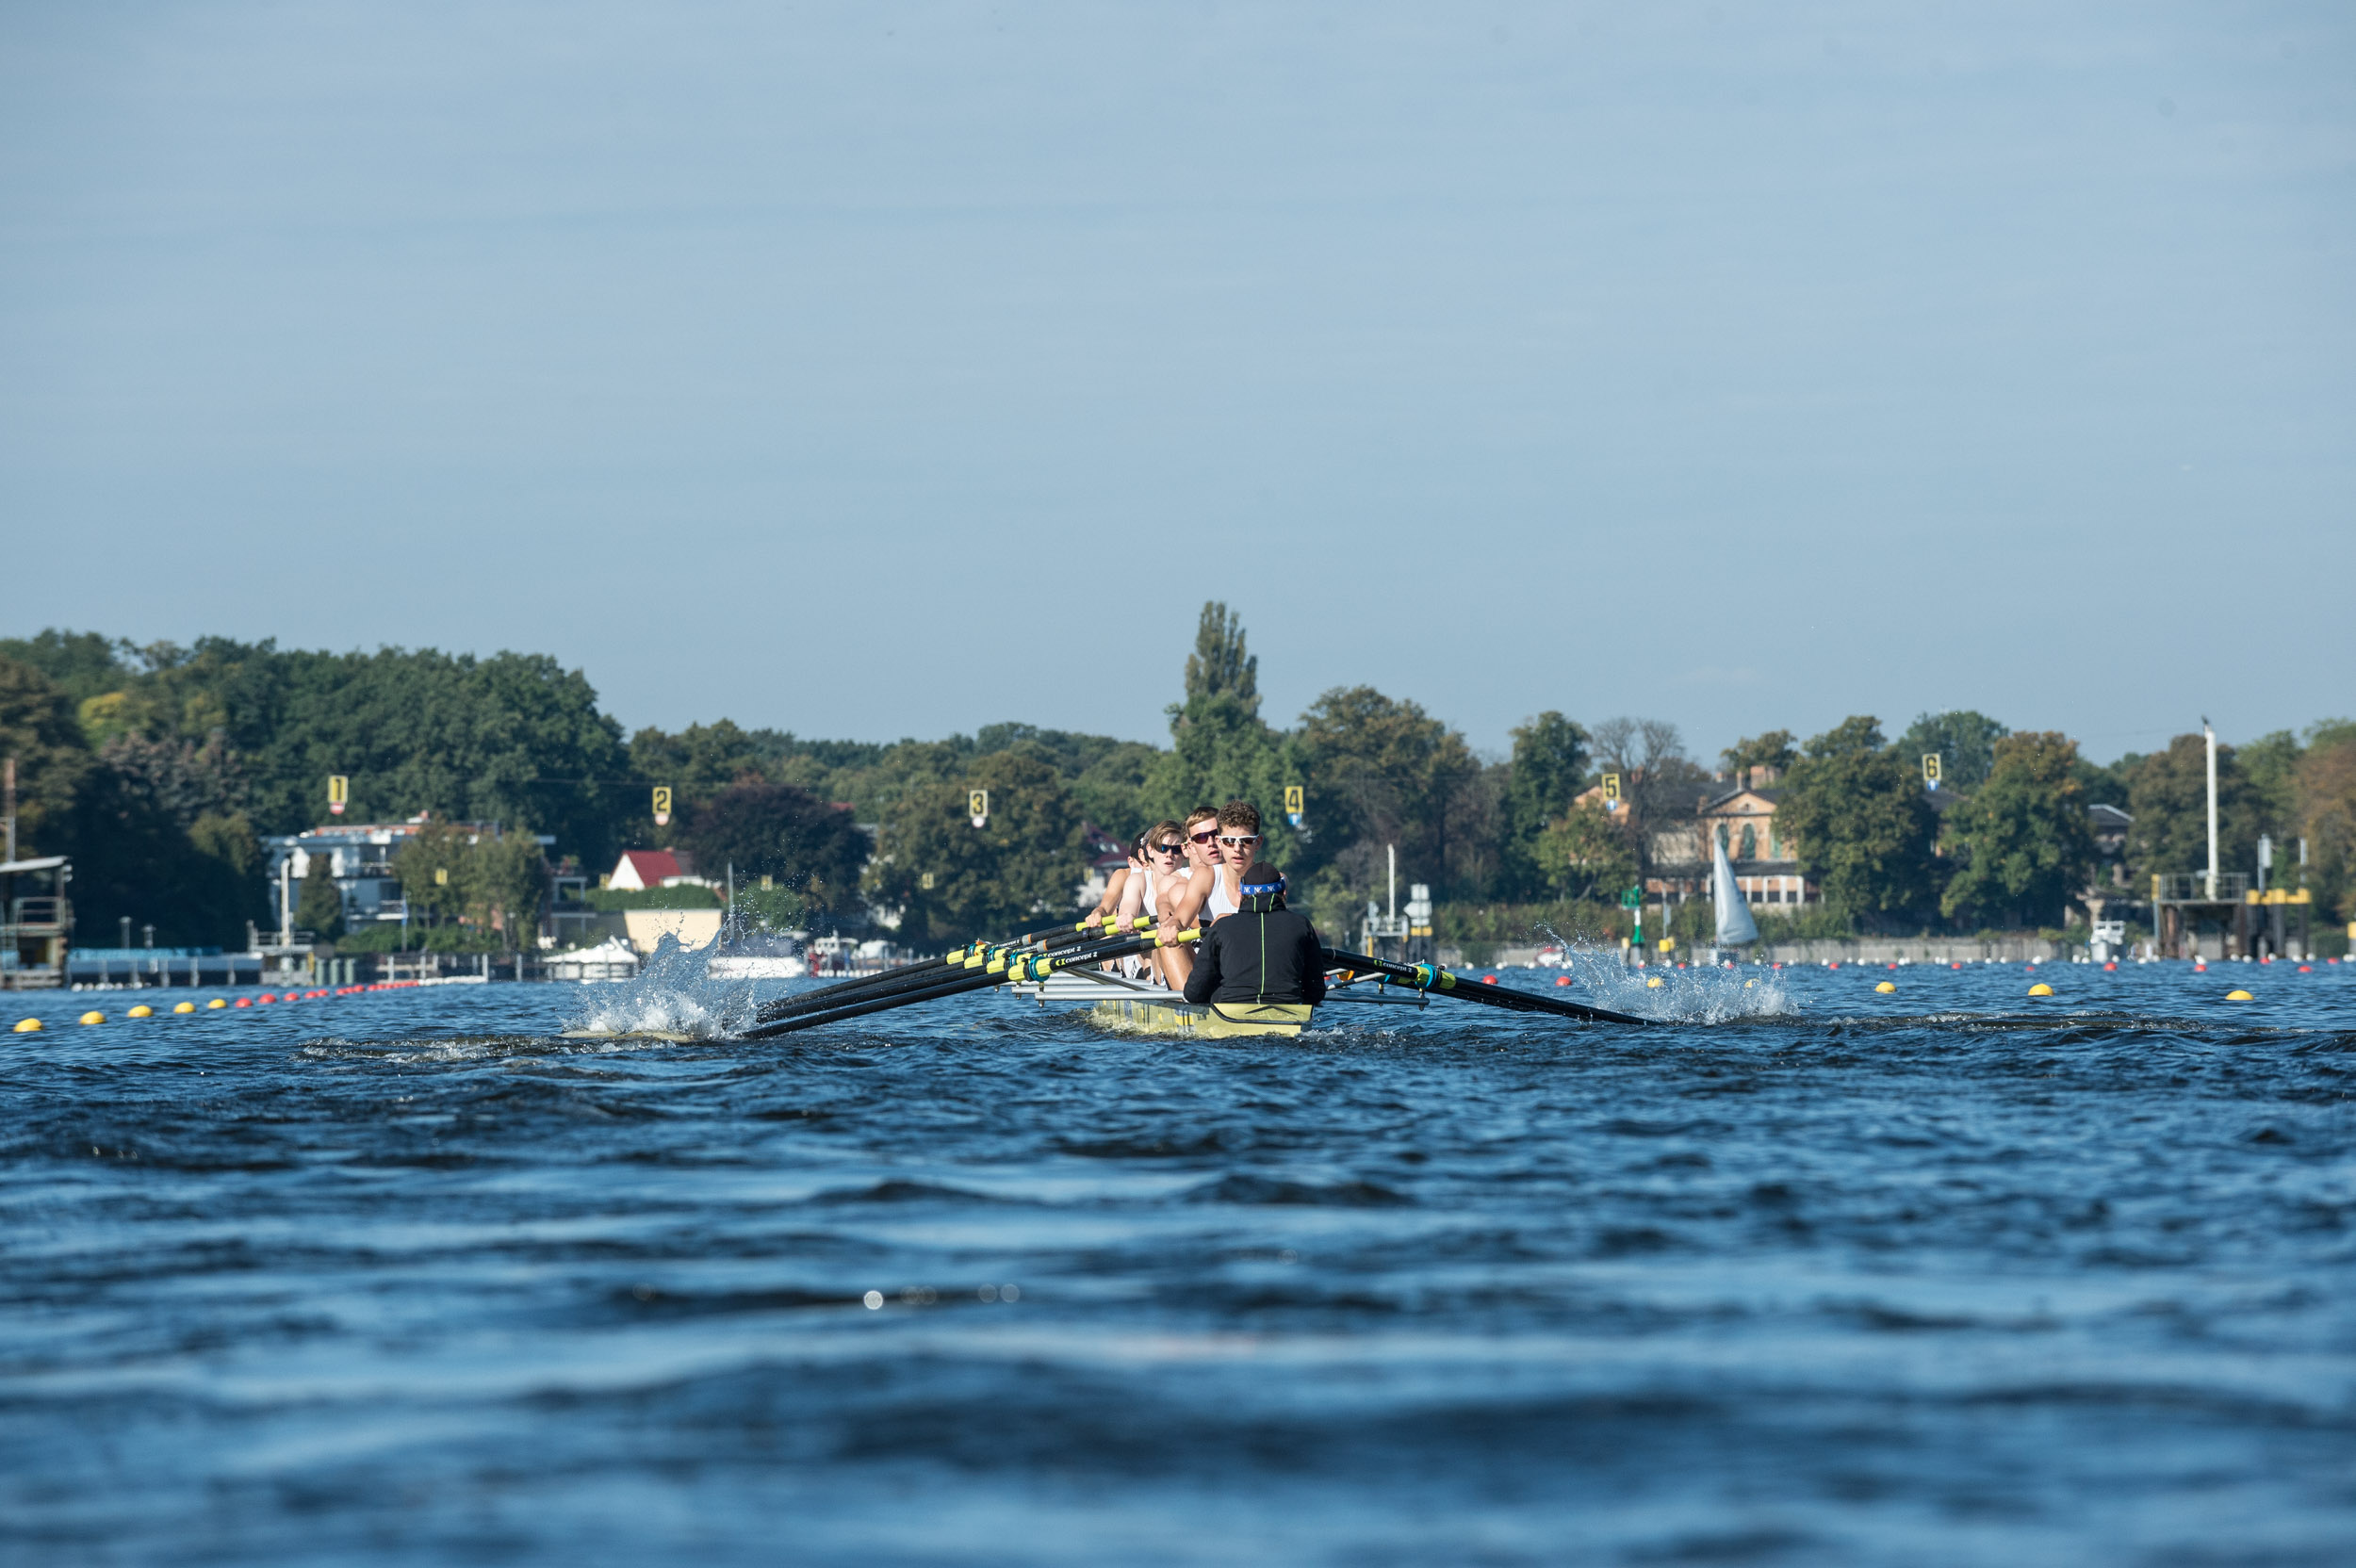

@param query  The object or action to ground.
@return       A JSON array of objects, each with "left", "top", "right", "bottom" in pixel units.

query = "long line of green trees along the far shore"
[{"left": 0, "top": 603, "right": 2356, "bottom": 946}]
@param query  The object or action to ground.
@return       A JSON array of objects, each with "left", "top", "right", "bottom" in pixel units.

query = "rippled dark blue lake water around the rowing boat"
[{"left": 0, "top": 965, "right": 2356, "bottom": 1568}]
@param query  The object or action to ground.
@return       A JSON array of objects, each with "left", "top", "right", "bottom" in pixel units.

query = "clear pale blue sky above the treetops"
[{"left": 0, "top": 0, "right": 2356, "bottom": 759}]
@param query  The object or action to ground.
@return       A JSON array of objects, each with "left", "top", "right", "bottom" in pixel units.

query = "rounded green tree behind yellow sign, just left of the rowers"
[{"left": 867, "top": 746, "right": 1087, "bottom": 946}]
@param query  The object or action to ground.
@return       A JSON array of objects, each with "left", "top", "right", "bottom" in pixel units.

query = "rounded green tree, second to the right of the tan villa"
[{"left": 1939, "top": 732, "right": 2095, "bottom": 927}]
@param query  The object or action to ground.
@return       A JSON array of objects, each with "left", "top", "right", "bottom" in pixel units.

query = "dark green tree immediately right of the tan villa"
[{"left": 1776, "top": 716, "right": 1939, "bottom": 925}]
